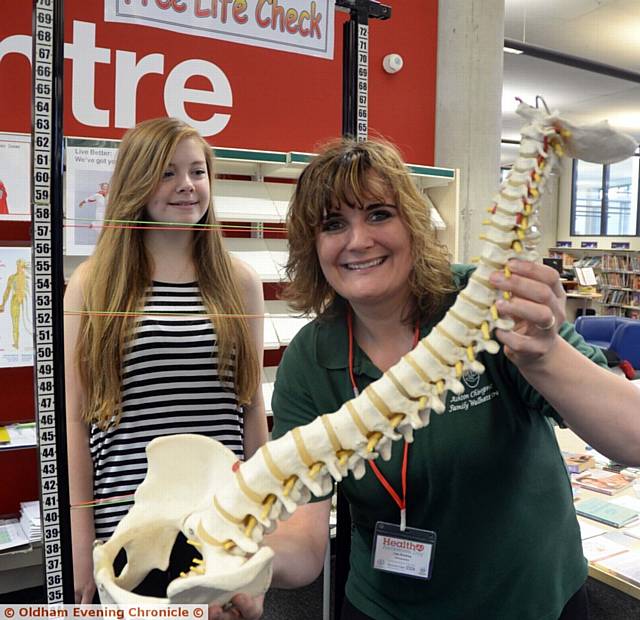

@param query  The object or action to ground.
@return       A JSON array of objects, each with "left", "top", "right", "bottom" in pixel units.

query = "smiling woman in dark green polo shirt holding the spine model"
[{"left": 220, "top": 140, "right": 640, "bottom": 620}]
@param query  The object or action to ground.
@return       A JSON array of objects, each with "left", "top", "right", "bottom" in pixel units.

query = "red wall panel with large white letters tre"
[{"left": 0, "top": 0, "right": 437, "bottom": 164}]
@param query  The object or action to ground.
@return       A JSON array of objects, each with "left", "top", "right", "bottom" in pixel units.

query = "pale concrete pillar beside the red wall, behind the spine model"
[{"left": 435, "top": 0, "right": 504, "bottom": 262}]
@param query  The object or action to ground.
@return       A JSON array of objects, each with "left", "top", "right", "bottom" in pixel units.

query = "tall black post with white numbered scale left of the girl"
[{"left": 31, "top": 0, "right": 74, "bottom": 604}]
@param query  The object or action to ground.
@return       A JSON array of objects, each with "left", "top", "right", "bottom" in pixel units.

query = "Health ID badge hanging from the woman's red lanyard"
[{"left": 371, "top": 521, "right": 436, "bottom": 579}]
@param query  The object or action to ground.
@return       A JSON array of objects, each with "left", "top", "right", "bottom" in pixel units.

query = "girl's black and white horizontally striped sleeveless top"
[{"left": 90, "top": 282, "right": 243, "bottom": 539}]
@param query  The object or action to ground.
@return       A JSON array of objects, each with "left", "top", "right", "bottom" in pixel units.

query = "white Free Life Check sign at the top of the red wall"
[{"left": 104, "top": 0, "right": 335, "bottom": 60}]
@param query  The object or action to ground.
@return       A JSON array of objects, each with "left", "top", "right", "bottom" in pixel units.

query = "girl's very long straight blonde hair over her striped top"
[{"left": 76, "top": 118, "right": 260, "bottom": 428}]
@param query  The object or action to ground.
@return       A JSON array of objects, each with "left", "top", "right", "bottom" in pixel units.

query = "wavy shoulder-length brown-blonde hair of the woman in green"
[{"left": 282, "top": 138, "right": 455, "bottom": 321}]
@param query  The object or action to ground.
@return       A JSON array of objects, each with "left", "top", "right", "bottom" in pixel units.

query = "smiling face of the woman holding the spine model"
[{"left": 316, "top": 175, "right": 413, "bottom": 308}]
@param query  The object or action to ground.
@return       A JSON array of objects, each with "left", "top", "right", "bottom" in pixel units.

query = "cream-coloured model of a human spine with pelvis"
[{"left": 94, "top": 104, "right": 635, "bottom": 603}]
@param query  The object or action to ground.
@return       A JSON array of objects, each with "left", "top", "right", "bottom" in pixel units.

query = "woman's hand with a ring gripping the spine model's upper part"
[{"left": 491, "top": 260, "right": 566, "bottom": 368}]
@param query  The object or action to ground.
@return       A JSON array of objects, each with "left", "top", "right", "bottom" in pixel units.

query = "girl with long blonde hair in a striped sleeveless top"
[{"left": 65, "top": 118, "right": 267, "bottom": 603}]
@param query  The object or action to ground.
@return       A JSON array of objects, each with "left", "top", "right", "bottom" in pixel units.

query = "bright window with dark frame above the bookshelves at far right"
[{"left": 571, "top": 156, "right": 640, "bottom": 237}]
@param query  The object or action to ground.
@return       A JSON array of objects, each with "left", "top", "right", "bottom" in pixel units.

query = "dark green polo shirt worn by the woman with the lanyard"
[{"left": 272, "top": 266, "right": 605, "bottom": 620}]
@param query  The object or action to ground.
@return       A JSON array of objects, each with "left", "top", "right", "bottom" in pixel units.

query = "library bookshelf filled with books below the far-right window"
[{"left": 549, "top": 248, "right": 640, "bottom": 319}]
